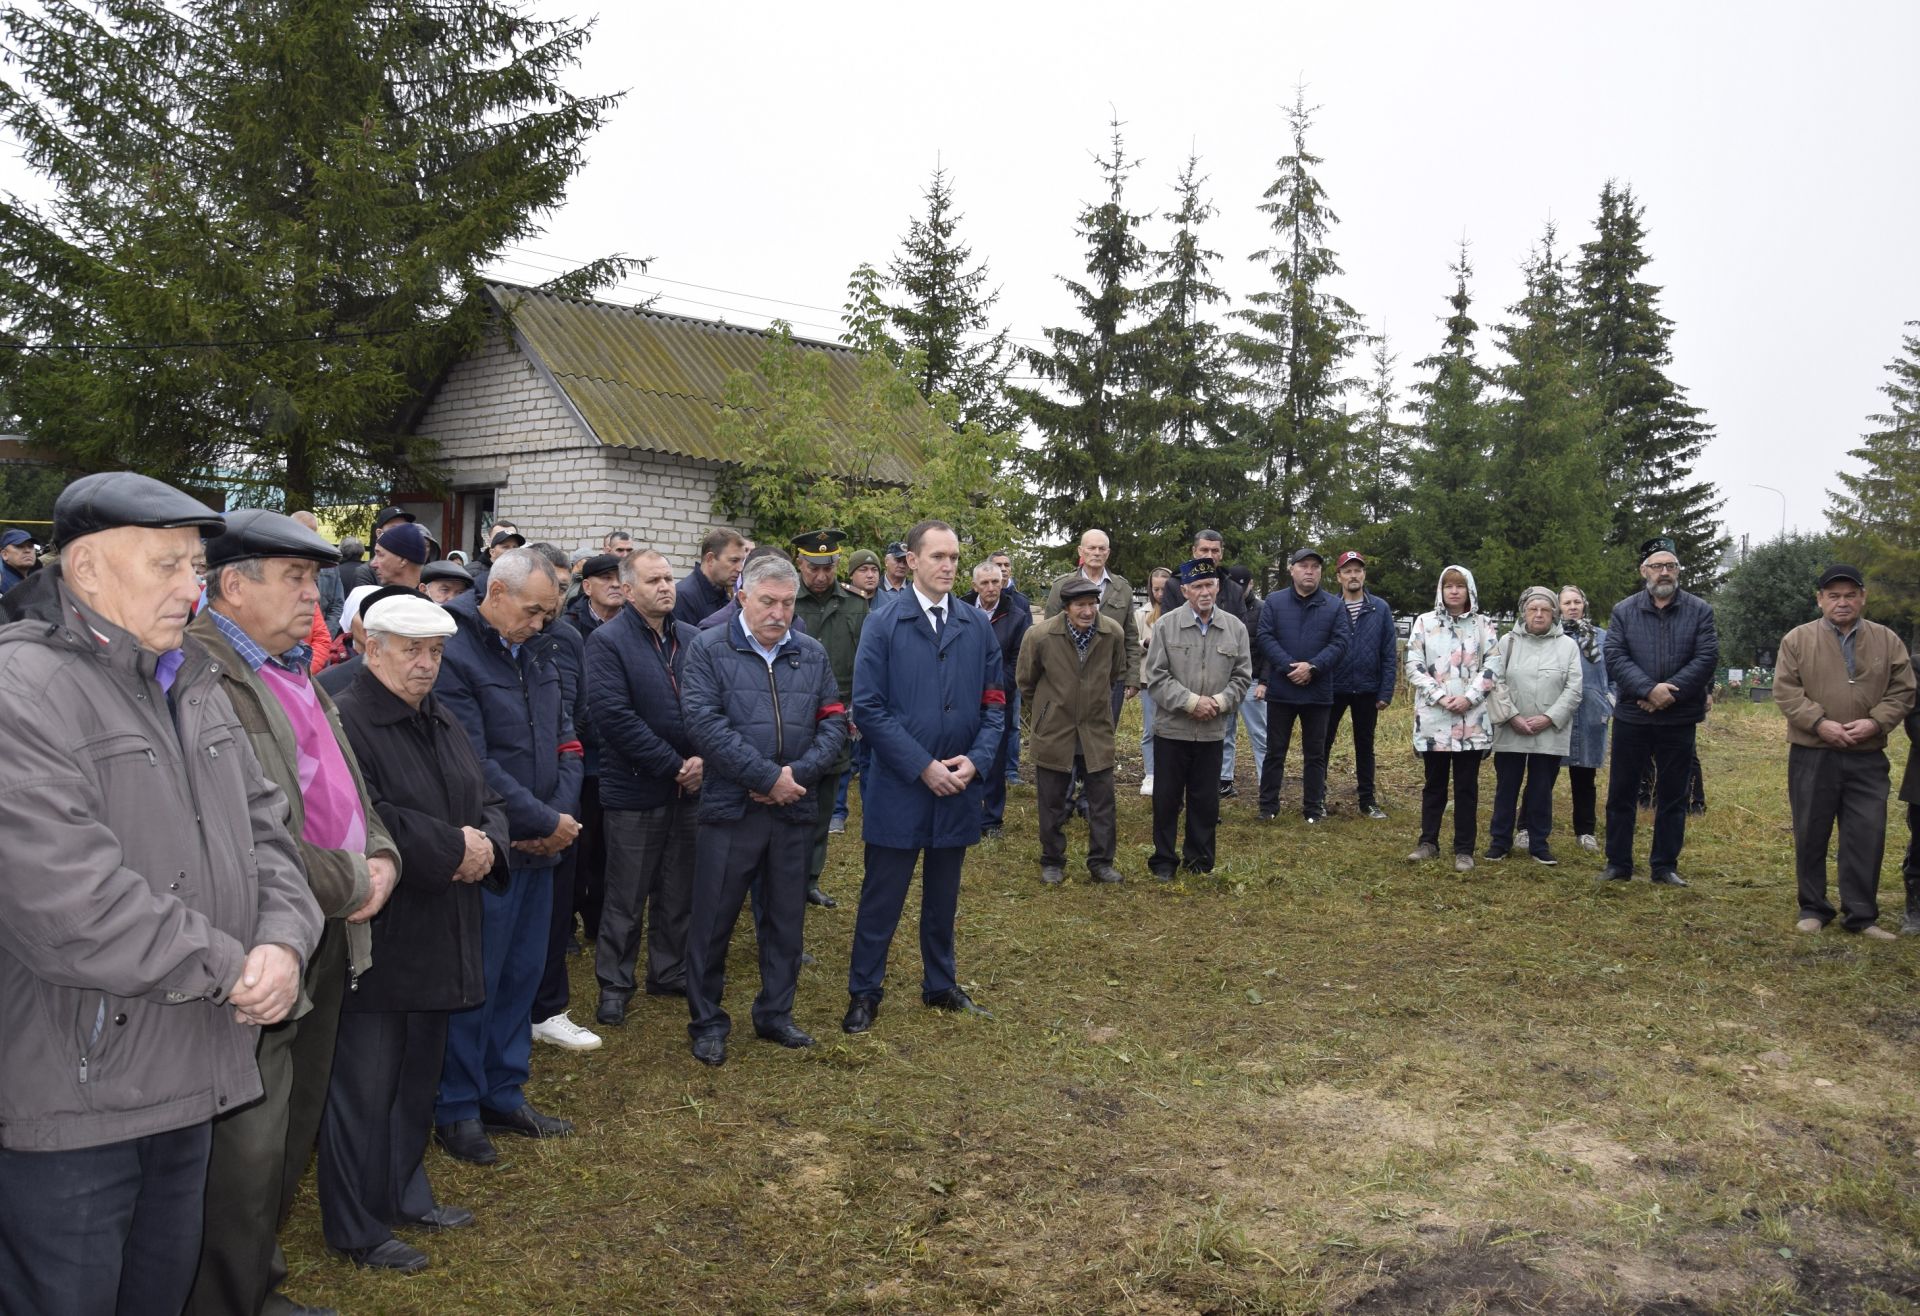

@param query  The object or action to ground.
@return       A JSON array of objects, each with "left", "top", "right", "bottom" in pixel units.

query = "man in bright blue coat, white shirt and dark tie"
[{"left": 841, "top": 521, "right": 1006, "bottom": 1034}]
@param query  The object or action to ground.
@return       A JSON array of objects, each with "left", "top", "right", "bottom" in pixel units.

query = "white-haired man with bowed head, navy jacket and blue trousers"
[{"left": 434, "top": 548, "right": 582, "bottom": 1164}]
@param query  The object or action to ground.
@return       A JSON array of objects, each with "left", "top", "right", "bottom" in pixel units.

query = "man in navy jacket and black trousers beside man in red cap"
[{"left": 1254, "top": 548, "right": 1352, "bottom": 822}]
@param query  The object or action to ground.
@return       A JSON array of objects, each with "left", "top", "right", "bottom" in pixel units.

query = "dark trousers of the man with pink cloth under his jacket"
[{"left": 186, "top": 918, "right": 348, "bottom": 1316}]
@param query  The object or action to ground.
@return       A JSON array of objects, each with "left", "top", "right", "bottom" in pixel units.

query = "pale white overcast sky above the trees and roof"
[{"left": 483, "top": 0, "right": 1920, "bottom": 542}]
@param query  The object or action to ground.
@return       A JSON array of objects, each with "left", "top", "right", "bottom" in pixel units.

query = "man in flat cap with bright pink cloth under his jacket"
[{"left": 186, "top": 509, "right": 399, "bottom": 1316}]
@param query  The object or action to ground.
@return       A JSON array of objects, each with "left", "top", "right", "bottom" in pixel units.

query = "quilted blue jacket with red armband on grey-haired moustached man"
[{"left": 680, "top": 621, "right": 847, "bottom": 822}]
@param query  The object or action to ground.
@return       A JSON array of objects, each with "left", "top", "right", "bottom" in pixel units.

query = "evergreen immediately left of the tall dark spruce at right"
[{"left": 1476, "top": 223, "right": 1630, "bottom": 609}]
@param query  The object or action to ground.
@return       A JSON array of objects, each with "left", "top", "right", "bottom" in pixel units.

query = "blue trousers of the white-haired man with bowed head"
[{"left": 434, "top": 868, "right": 553, "bottom": 1124}]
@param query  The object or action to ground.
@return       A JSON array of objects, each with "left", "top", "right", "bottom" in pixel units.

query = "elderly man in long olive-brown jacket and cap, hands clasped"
[{"left": 1016, "top": 578, "right": 1135, "bottom": 886}]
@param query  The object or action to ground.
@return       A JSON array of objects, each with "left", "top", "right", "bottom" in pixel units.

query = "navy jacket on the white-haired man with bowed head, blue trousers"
[{"left": 434, "top": 594, "right": 584, "bottom": 868}]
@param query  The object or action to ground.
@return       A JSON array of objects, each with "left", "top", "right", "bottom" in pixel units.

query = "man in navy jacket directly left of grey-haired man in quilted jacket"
[{"left": 588, "top": 549, "right": 707, "bottom": 1028}]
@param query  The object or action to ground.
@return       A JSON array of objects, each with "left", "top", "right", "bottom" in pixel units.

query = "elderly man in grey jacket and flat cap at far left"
[{"left": 0, "top": 471, "right": 321, "bottom": 1312}]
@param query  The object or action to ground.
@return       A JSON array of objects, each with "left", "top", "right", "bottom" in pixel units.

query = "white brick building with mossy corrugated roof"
[{"left": 397, "top": 284, "right": 914, "bottom": 567}]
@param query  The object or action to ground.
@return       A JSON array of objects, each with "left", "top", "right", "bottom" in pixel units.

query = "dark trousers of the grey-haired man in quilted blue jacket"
[{"left": 687, "top": 803, "right": 802, "bottom": 1037}]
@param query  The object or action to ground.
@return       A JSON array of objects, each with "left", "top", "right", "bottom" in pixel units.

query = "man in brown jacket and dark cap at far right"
[{"left": 1774, "top": 563, "right": 1914, "bottom": 941}]
